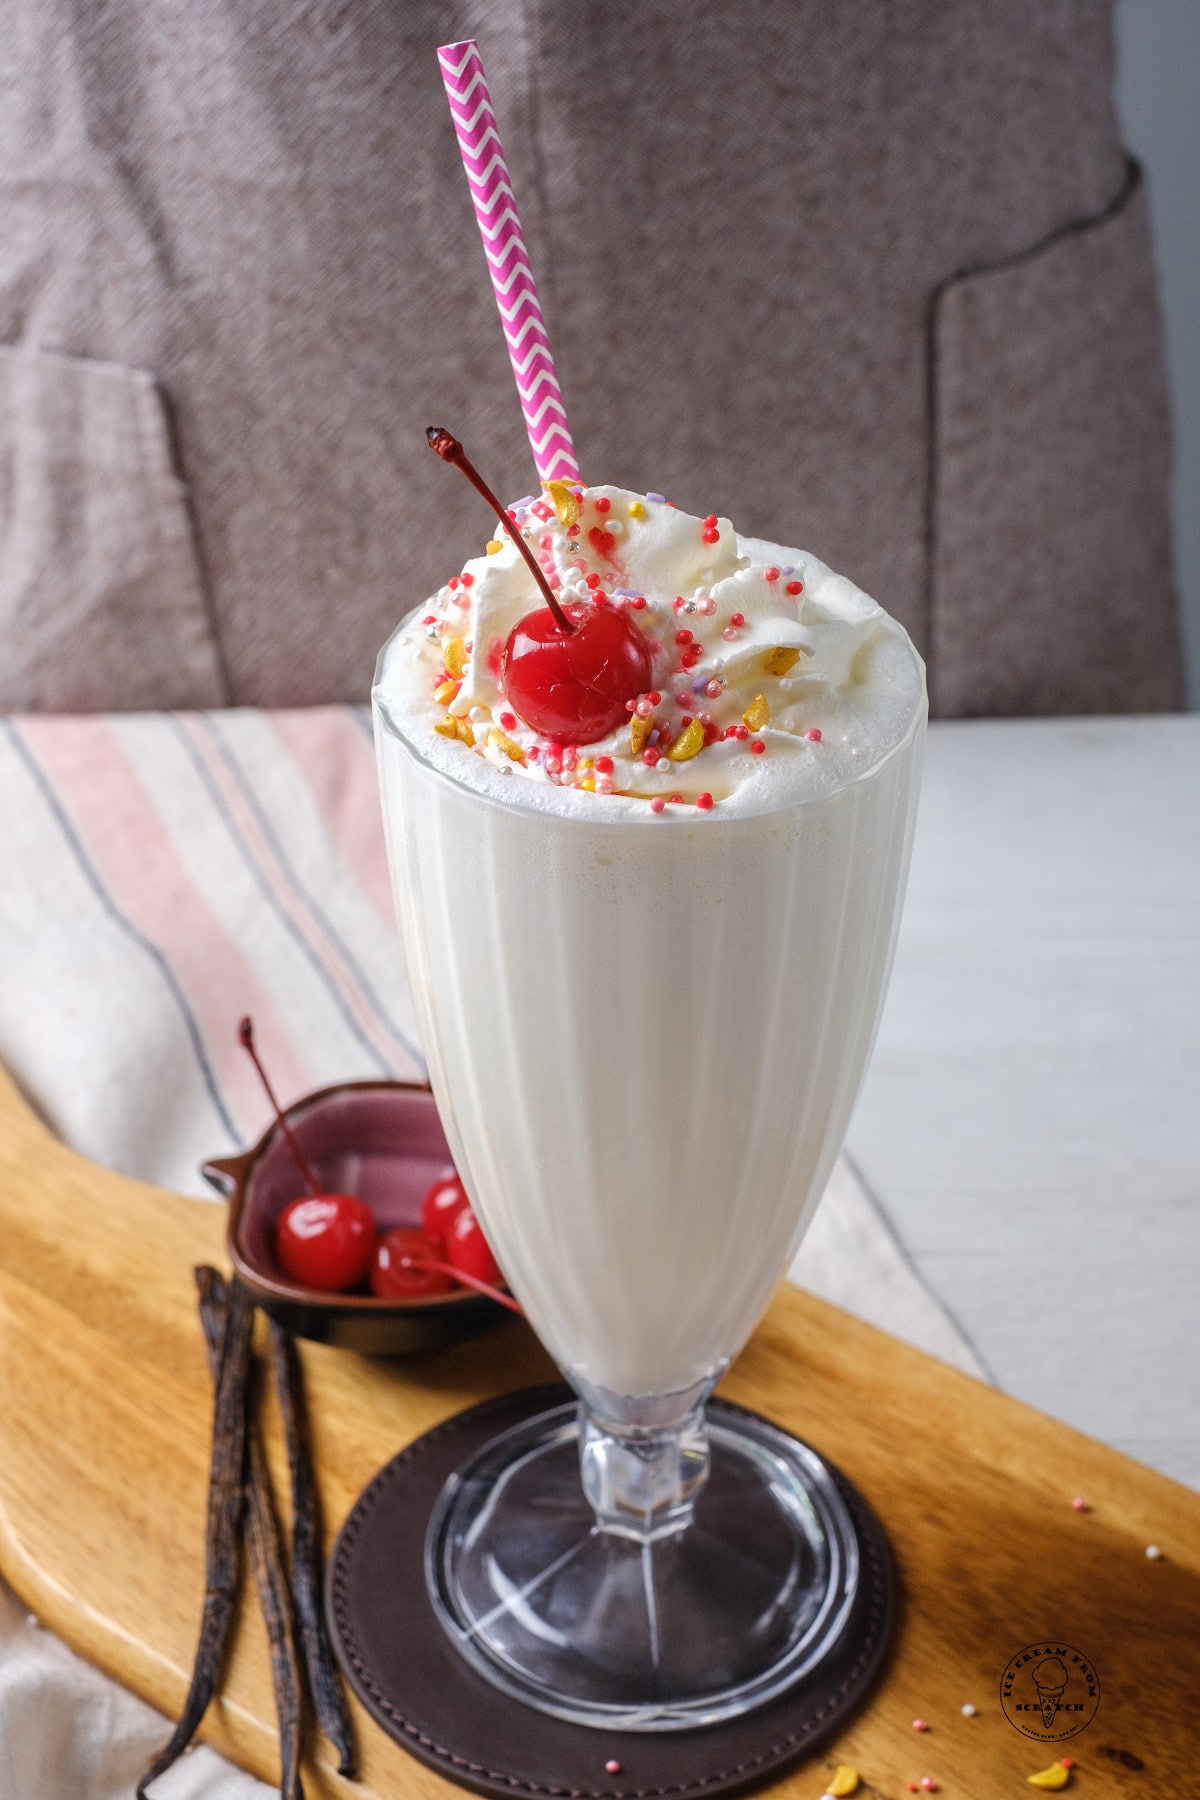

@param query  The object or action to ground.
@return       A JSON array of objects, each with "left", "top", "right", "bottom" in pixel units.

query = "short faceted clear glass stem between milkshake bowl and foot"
[{"left": 579, "top": 1402, "right": 709, "bottom": 1543}]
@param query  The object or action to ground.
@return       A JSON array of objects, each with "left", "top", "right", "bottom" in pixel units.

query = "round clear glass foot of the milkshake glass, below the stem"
[{"left": 425, "top": 1402, "right": 858, "bottom": 1732}]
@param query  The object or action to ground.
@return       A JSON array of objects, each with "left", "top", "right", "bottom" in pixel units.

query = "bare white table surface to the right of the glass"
[{"left": 849, "top": 716, "right": 1200, "bottom": 1487}]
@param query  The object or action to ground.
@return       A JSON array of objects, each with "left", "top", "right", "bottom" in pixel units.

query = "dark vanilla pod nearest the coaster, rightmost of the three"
[{"left": 270, "top": 1319, "right": 354, "bottom": 1775}]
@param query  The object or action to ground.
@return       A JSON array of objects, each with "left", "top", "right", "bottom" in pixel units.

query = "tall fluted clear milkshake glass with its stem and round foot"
[{"left": 374, "top": 622, "right": 925, "bottom": 1732}]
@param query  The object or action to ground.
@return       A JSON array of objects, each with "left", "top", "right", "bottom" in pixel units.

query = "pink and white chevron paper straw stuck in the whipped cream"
[{"left": 437, "top": 38, "right": 581, "bottom": 481}]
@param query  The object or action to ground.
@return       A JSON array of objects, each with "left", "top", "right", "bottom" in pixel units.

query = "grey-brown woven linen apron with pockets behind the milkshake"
[{"left": 0, "top": 0, "right": 1180, "bottom": 713}]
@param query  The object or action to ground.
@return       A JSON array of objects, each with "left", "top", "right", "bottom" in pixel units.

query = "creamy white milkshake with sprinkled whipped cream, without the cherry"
[{"left": 374, "top": 484, "right": 925, "bottom": 1397}]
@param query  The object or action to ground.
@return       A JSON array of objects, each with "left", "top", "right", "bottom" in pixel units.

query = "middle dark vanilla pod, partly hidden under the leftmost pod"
[{"left": 196, "top": 1267, "right": 304, "bottom": 1800}]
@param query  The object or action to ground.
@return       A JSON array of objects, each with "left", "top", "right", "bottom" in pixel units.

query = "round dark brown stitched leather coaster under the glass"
[{"left": 326, "top": 1386, "right": 894, "bottom": 1800}]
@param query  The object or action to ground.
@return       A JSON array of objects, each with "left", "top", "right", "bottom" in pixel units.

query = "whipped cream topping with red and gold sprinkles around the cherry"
[{"left": 376, "top": 482, "right": 923, "bottom": 819}]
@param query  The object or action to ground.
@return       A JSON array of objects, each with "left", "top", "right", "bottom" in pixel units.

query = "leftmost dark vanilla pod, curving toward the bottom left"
[{"left": 137, "top": 1282, "right": 254, "bottom": 1800}]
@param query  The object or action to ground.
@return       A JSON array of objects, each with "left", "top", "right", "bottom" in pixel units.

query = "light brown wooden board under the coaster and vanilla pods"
[{"left": 0, "top": 1071, "right": 1200, "bottom": 1800}]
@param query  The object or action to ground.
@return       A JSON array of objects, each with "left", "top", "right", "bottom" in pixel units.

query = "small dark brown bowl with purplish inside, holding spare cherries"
[{"left": 201, "top": 1082, "right": 506, "bottom": 1355}]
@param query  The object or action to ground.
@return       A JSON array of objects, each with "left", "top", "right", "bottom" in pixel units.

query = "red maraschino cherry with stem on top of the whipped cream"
[{"left": 425, "top": 425, "right": 653, "bottom": 743}]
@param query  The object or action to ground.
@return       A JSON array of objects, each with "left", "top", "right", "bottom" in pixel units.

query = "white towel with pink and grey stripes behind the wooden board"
[{"left": 0, "top": 707, "right": 979, "bottom": 1373}]
